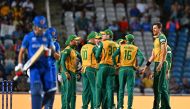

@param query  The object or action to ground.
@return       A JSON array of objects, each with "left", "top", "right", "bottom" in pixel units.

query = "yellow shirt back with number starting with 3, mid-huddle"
[{"left": 100, "top": 40, "right": 117, "bottom": 65}]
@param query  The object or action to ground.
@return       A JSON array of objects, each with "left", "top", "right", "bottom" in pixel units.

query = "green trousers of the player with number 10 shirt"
[{"left": 82, "top": 67, "right": 96, "bottom": 109}]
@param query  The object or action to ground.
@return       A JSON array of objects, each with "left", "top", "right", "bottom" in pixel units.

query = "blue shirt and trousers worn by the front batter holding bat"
[{"left": 21, "top": 31, "right": 56, "bottom": 109}]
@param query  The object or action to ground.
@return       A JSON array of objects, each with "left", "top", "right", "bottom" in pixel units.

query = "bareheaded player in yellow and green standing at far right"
[{"left": 142, "top": 22, "right": 171, "bottom": 109}]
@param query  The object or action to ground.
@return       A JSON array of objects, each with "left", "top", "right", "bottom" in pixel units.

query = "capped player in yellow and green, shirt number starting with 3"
[{"left": 95, "top": 29, "right": 117, "bottom": 109}]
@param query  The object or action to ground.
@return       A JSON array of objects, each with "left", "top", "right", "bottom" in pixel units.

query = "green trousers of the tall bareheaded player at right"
[{"left": 153, "top": 62, "right": 171, "bottom": 109}]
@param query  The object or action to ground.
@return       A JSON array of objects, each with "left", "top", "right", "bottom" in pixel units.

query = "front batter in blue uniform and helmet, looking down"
[{"left": 17, "top": 16, "right": 58, "bottom": 109}]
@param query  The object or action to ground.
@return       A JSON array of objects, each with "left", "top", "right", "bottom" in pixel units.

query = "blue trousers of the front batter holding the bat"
[{"left": 29, "top": 64, "right": 56, "bottom": 109}]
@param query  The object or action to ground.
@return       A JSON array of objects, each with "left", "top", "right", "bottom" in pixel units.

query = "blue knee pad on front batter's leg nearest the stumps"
[{"left": 31, "top": 82, "right": 42, "bottom": 95}]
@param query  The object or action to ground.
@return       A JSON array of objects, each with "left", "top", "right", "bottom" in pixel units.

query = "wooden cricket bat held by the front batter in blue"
[{"left": 13, "top": 45, "right": 46, "bottom": 80}]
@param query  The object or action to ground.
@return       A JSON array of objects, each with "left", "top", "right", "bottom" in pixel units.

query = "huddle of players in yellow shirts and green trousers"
[{"left": 57, "top": 23, "right": 171, "bottom": 109}]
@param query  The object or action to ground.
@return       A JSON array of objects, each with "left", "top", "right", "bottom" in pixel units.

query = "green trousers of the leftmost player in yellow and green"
[{"left": 61, "top": 72, "right": 76, "bottom": 109}]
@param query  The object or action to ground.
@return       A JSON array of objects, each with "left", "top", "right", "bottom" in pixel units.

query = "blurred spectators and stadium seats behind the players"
[{"left": 0, "top": 0, "right": 190, "bottom": 95}]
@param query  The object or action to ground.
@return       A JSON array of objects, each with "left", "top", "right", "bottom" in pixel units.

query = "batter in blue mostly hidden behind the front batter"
[{"left": 43, "top": 27, "right": 60, "bottom": 109}]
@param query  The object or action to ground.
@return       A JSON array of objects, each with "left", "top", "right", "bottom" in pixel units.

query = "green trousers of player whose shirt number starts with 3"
[{"left": 96, "top": 64, "right": 115, "bottom": 109}]
